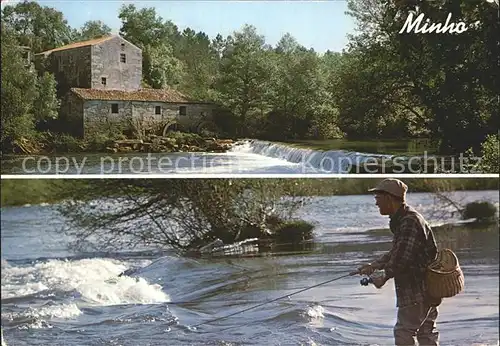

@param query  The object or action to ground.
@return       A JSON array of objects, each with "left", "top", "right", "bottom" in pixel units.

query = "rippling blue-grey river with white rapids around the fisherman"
[{"left": 1, "top": 191, "right": 499, "bottom": 346}]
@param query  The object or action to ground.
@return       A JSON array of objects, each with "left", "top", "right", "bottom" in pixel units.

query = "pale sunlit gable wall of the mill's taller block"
[{"left": 91, "top": 36, "right": 142, "bottom": 90}]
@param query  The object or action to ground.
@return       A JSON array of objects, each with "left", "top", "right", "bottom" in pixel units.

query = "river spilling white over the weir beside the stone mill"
[{"left": 2, "top": 140, "right": 458, "bottom": 175}]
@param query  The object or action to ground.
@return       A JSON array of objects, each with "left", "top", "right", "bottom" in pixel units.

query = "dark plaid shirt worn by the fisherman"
[{"left": 376, "top": 204, "right": 440, "bottom": 307}]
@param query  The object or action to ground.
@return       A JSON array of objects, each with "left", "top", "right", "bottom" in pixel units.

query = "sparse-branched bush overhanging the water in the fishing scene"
[{"left": 59, "top": 179, "right": 305, "bottom": 253}]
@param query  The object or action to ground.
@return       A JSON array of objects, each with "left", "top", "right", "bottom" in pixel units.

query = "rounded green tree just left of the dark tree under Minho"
[{"left": 329, "top": 44, "right": 429, "bottom": 138}]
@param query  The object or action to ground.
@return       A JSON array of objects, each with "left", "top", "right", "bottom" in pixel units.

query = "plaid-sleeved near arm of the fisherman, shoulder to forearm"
[{"left": 384, "top": 219, "right": 421, "bottom": 280}]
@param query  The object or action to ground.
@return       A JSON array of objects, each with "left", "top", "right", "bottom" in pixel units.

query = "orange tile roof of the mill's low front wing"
[{"left": 71, "top": 88, "right": 195, "bottom": 103}]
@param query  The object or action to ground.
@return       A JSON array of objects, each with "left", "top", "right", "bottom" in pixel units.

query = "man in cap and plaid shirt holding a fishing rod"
[{"left": 357, "top": 179, "right": 442, "bottom": 346}]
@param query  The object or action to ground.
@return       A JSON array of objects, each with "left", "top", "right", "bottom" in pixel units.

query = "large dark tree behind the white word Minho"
[{"left": 348, "top": 0, "right": 499, "bottom": 153}]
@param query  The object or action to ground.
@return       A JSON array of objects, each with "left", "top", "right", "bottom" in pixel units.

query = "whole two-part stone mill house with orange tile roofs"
[{"left": 37, "top": 35, "right": 215, "bottom": 137}]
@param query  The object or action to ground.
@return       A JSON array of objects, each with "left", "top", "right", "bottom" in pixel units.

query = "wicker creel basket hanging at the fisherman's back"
[{"left": 427, "top": 249, "right": 465, "bottom": 298}]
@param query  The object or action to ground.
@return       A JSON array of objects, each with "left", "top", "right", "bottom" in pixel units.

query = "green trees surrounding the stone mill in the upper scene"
[{"left": 2, "top": 0, "right": 500, "bottom": 159}]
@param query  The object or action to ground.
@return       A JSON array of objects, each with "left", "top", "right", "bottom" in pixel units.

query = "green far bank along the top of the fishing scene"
[{"left": 0, "top": 178, "right": 499, "bottom": 207}]
